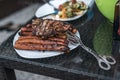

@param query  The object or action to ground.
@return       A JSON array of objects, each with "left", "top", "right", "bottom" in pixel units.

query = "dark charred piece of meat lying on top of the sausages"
[{"left": 33, "top": 19, "right": 77, "bottom": 38}]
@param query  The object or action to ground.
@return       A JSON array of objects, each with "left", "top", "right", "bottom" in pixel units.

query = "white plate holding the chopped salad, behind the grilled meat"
[{"left": 35, "top": 0, "right": 91, "bottom": 21}]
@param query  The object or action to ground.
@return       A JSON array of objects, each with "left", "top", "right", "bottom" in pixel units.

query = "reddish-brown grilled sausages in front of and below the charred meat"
[{"left": 14, "top": 36, "right": 69, "bottom": 52}]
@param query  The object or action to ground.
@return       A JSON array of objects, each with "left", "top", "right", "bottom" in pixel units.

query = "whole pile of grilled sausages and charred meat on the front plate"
[{"left": 14, "top": 19, "right": 77, "bottom": 53}]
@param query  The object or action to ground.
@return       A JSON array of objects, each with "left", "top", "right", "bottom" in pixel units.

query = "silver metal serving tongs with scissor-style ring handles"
[{"left": 67, "top": 31, "right": 116, "bottom": 70}]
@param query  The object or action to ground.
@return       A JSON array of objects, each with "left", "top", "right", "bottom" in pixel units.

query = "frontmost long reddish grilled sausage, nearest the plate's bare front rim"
[{"left": 14, "top": 43, "right": 69, "bottom": 53}]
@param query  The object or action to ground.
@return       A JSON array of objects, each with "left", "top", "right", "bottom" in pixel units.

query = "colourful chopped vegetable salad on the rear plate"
[{"left": 56, "top": 0, "right": 87, "bottom": 19}]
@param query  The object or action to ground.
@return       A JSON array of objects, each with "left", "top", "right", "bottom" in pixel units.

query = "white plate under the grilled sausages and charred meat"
[{"left": 13, "top": 32, "right": 80, "bottom": 59}]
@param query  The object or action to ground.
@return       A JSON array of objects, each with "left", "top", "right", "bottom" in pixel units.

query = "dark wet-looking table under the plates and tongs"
[{"left": 0, "top": 2, "right": 120, "bottom": 80}]
